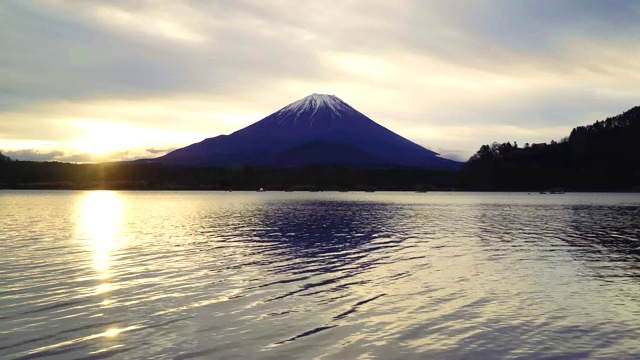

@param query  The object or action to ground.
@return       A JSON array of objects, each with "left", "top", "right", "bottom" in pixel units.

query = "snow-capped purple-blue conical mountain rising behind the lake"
[{"left": 149, "top": 94, "right": 462, "bottom": 169}]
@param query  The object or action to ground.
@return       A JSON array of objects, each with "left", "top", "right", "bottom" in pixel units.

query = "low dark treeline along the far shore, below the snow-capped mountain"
[{"left": 0, "top": 161, "right": 458, "bottom": 191}]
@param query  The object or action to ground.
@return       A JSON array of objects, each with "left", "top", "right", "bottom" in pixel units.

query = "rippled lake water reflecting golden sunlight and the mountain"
[{"left": 0, "top": 191, "right": 640, "bottom": 359}]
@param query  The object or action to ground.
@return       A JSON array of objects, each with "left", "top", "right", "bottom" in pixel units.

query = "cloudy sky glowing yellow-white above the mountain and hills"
[{"left": 0, "top": 0, "right": 640, "bottom": 162}]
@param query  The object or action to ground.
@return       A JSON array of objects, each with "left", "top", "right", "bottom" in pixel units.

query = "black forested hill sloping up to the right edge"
[{"left": 461, "top": 106, "right": 640, "bottom": 191}]
